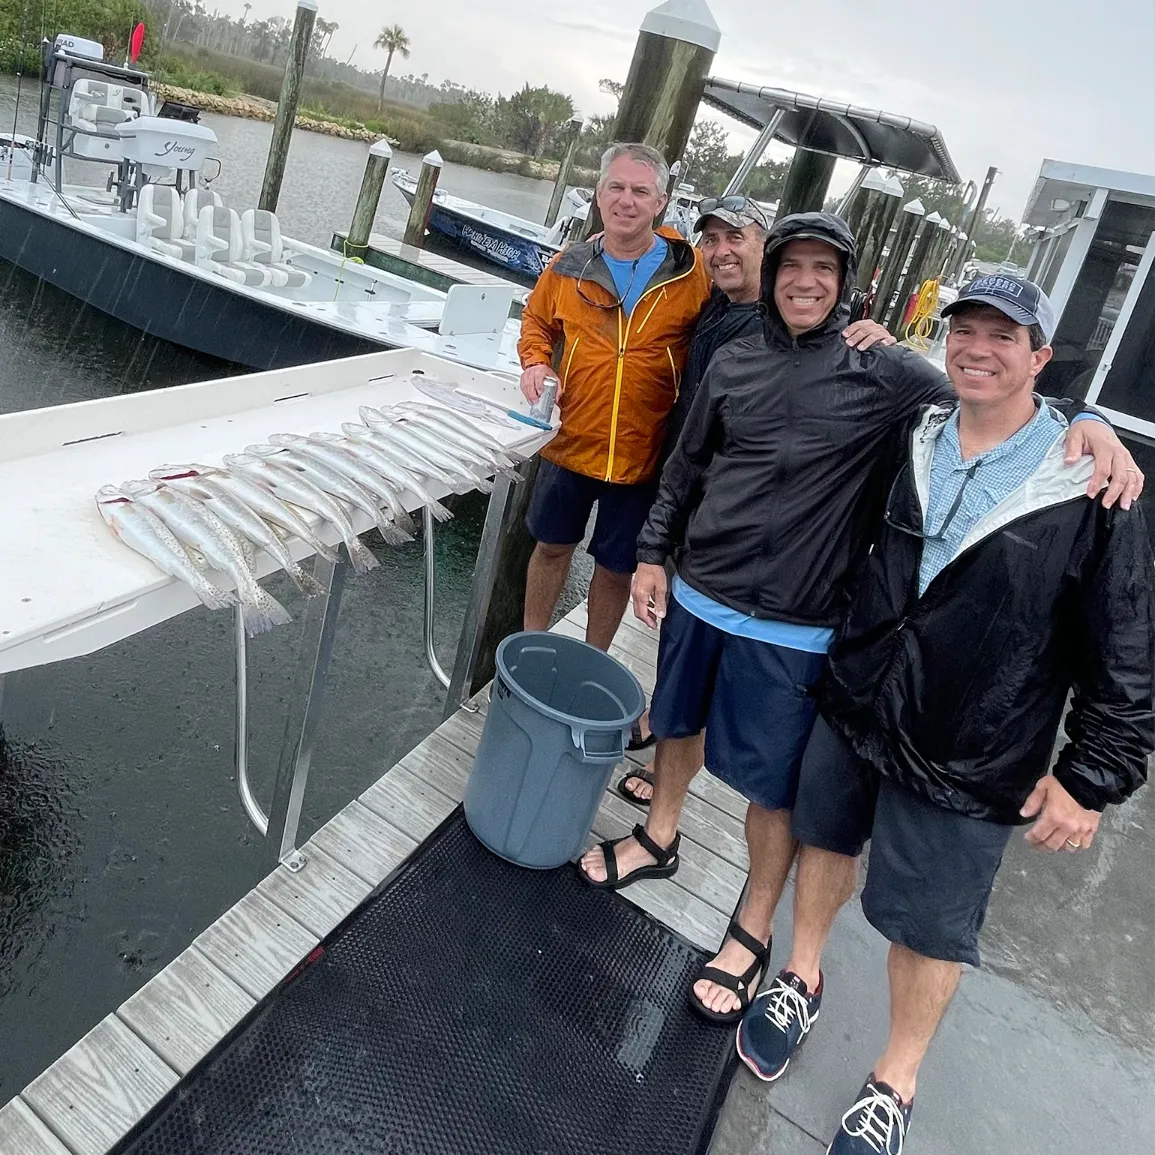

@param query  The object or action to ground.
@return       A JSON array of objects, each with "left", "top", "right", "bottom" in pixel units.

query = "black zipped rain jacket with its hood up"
[{"left": 638, "top": 213, "right": 953, "bottom": 627}]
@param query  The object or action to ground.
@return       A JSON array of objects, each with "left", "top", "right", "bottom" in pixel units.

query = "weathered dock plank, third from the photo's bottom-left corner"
[{"left": 117, "top": 946, "right": 255, "bottom": 1075}]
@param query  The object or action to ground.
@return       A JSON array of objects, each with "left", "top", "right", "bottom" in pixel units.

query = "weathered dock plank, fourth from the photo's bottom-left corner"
[{"left": 193, "top": 891, "right": 319, "bottom": 999}]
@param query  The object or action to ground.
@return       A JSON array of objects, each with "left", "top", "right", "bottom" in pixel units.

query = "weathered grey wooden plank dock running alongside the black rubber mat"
[{"left": 0, "top": 605, "right": 746, "bottom": 1155}]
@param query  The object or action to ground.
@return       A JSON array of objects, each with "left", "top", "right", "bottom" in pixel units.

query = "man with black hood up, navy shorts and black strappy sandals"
[{"left": 581, "top": 213, "right": 1141, "bottom": 1022}]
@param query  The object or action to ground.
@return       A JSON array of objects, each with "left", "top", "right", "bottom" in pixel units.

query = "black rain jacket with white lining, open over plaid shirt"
[{"left": 820, "top": 404, "right": 1155, "bottom": 825}]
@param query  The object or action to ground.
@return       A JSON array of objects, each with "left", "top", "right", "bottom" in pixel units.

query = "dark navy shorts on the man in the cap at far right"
[{"left": 792, "top": 718, "right": 1014, "bottom": 967}]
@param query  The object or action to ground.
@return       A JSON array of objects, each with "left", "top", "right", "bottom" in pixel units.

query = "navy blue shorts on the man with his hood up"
[{"left": 650, "top": 594, "right": 826, "bottom": 810}]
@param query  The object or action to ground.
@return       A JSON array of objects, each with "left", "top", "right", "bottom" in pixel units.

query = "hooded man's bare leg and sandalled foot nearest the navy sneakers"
[{"left": 694, "top": 803, "right": 796, "bottom": 1014}]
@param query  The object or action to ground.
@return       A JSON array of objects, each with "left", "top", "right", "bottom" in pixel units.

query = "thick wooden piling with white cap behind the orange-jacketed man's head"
[{"left": 586, "top": 0, "right": 722, "bottom": 236}]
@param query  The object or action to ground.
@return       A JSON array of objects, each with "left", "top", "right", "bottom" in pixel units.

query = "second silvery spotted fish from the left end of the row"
[{"left": 120, "top": 482, "right": 292, "bottom": 638}]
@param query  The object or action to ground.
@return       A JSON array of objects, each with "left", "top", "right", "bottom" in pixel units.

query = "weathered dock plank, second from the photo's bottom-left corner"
[{"left": 21, "top": 1015, "right": 179, "bottom": 1155}]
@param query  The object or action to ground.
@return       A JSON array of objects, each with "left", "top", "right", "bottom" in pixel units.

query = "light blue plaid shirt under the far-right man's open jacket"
[{"left": 918, "top": 398, "right": 1067, "bottom": 595}]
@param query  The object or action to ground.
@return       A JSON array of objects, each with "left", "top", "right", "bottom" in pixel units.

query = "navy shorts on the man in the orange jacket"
[{"left": 526, "top": 459, "right": 657, "bottom": 574}]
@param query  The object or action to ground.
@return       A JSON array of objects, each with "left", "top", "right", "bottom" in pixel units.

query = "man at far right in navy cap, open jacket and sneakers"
[{"left": 738, "top": 276, "right": 1155, "bottom": 1155}]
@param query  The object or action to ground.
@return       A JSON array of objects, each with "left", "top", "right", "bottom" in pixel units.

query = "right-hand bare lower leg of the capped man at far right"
[{"left": 874, "top": 942, "right": 962, "bottom": 1103}]
